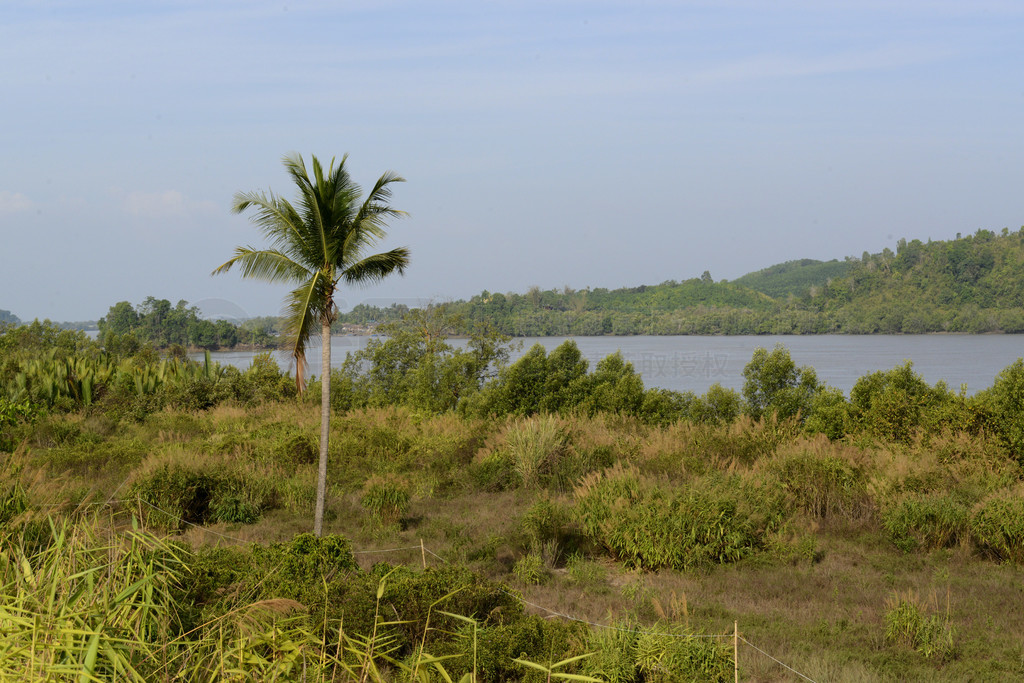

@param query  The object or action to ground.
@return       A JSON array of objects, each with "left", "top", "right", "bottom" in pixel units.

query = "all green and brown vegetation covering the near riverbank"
[{"left": 0, "top": 317, "right": 1024, "bottom": 682}]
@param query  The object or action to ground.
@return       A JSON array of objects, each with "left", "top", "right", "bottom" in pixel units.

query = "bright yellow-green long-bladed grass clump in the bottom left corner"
[{"left": 0, "top": 518, "right": 183, "bottom": 681}]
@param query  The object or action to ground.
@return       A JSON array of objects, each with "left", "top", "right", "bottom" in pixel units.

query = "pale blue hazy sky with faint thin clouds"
[{"left": 0, "top": 0, "right": 1024, "bottom": 321}]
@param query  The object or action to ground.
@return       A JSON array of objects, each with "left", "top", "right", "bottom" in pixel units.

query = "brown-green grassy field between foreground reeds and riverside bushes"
[{"left": 8, "top": 400, "right": 1024, "bottom": 681}]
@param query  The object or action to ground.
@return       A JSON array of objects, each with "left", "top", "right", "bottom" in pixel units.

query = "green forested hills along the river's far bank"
[{"left": 341, "top": 228, "right": 1024, "bottom": 336}]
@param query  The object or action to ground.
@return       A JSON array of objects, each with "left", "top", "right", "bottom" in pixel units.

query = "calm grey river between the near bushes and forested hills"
[{"left": 193, "top": 335, "right": 1024, "bottom": 394}]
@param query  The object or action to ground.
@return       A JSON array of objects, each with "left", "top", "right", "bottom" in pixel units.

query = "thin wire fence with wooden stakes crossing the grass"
[{"left": 9, "top": 492, "right": 817, "bottom": 683}]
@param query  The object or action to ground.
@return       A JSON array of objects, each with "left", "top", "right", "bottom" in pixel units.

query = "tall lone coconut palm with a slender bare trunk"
[{"left": 213, "top": 154, "right": 409, "bottom": 537}]
